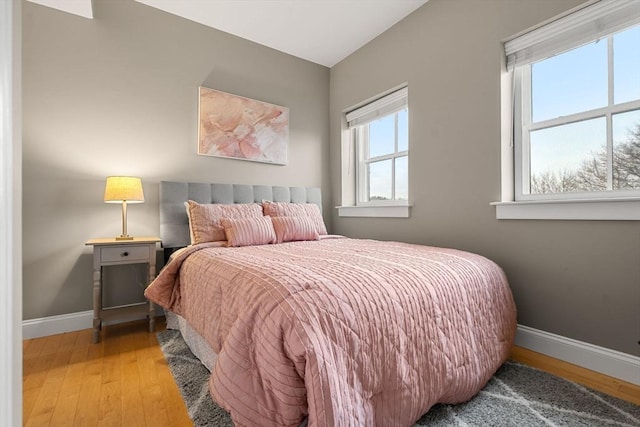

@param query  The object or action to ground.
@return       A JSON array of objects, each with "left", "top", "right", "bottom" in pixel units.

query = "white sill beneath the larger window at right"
[{"left": 491, "top": 197, "right": 640, "bottom": 221}]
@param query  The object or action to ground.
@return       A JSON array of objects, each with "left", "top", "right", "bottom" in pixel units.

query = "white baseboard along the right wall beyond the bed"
[{"left": 515, "top": 325, "right": 640, "bottom": 385}]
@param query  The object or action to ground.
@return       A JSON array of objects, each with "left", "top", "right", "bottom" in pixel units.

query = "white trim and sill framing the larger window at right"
[{"left": 491, "top": 0, "right": 640, "bottom": 221}]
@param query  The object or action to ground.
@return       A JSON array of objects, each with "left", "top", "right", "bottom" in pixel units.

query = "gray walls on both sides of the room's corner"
[{"left": 23, "top": 0, "right": 640, "bottom": 355}]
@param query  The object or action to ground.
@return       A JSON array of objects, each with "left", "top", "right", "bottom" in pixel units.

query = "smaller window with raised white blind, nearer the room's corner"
[{"left": 346, "top": 87, "right": 409, "bottom": 214}]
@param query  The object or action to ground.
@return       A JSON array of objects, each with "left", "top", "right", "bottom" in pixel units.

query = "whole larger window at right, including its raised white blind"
[{"left": 503, "top": 0, "right": 640, "bottom": 219}]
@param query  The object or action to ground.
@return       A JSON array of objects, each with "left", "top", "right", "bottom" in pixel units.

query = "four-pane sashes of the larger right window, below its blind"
[{"left": 516, "top": 25, "right": 640, "bottom": 200}]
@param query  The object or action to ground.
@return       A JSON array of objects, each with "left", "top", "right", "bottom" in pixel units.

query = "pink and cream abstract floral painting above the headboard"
[{"left": 198, "top": 86, "right": 289, "bottom": 165}]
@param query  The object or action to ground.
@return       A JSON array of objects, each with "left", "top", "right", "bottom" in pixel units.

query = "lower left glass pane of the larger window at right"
[{"left": 530, "top": 117, "right": 607, "bottom": 194}]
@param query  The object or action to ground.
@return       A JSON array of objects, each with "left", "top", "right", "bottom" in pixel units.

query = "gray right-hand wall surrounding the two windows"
[{"left": 330, "top": 0, "right": 640, "bottom": 355}]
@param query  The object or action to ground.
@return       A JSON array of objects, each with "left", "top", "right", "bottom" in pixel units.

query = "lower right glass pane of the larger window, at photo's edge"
[{"left": 613, "top": 110, "right": 640, "bottom": 190}]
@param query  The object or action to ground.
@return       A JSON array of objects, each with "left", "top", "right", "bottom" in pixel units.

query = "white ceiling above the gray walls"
[{"left": 25, "top": 0, "right": 428, "bottom": 67}]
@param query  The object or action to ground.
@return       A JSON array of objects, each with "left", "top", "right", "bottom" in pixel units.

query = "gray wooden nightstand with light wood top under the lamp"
[{"left": 85, "top": 237, "right": 161, "bottom": 343}]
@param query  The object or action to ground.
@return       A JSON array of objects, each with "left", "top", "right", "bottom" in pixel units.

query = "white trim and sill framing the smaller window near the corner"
[{"left": 336, "top": 83, "right": 412, "bottom": 218}]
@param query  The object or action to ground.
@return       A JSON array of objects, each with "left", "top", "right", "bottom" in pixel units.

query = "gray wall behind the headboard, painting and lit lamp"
[{"left": 23, "top": 0, "right": 330, "bottom": 319}]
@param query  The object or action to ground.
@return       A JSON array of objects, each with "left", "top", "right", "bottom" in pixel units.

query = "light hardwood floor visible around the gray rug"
[{"left": 23, "top": 319, "right": 640, "bottom": 427}]
